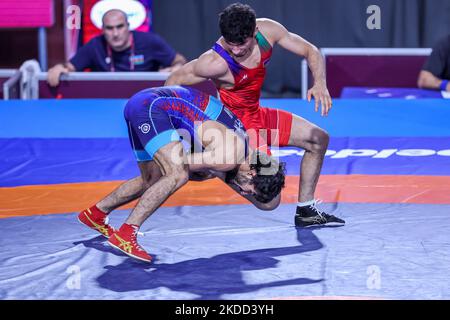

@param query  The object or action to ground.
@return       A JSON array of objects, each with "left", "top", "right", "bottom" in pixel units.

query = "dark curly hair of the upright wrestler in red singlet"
[{"left": 219, "top": 3, "right": 256, "bottom": 44}]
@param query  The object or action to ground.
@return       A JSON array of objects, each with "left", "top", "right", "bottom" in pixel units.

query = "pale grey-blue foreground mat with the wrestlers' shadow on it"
[{"left": 0, "top": 204, "right": 450, "bottom": 300}]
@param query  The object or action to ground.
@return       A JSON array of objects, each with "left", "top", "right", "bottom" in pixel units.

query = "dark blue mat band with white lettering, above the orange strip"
[{"left": 0, "top": 137, "right": 450, "bottom": 187}]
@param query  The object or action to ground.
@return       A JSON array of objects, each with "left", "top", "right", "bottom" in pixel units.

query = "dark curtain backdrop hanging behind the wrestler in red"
[{"left": 153, "top": 0, "right": 450, "bottom": 96}]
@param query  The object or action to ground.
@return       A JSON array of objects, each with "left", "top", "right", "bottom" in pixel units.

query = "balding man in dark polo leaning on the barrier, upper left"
[{"left": 47, "top": 9, "right": 186, "bottom": 86}]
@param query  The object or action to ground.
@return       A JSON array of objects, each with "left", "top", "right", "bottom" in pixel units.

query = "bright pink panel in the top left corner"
[{"left": 0, "top": 0, "right": 54, "bottom": 28}]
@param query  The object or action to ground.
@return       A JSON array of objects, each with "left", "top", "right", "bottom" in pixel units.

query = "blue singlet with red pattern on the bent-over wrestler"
[{"left": 124, "top": 86, "right": 248, "bottom": 161}]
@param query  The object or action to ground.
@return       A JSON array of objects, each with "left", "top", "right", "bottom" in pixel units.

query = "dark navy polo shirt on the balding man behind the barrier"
[{"left": 70, "top": 31, "right": 176, "bottom": 71}]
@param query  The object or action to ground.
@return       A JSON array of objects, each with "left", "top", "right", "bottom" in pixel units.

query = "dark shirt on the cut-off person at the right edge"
[{"left": 422, "top": 35, "right": 450, "bottom": 80}]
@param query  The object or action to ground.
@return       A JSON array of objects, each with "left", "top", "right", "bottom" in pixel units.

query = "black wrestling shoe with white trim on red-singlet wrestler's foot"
[{"left": 295, "top": 200, "right": 345, "bottom": 228}]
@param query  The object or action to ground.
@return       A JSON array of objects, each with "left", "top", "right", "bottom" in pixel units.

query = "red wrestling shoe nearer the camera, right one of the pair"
[{"left": 108, "top": 223, "right": 152, "bottom": 262}]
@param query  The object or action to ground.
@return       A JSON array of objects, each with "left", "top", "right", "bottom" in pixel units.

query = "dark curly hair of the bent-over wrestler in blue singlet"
[{"left": 250, "top": 151, "right": 286, "bottom": 203}]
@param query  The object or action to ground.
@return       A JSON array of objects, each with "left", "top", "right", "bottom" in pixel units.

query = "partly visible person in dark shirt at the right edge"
[{"left": 417, "top": 35, "right": 450, "bottom": 91}]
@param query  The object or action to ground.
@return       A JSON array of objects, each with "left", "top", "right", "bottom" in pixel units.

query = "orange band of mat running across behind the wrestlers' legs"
[{"left": 0, "top": 175, "right": 450, "bottom": 218}]
